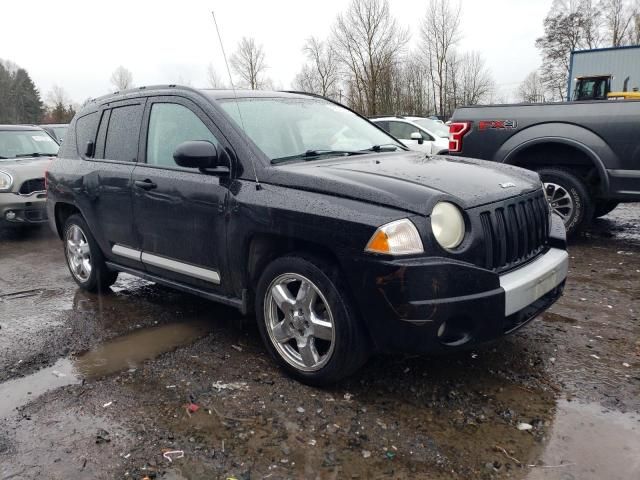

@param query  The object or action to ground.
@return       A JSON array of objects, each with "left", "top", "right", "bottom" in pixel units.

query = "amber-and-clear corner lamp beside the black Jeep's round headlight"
[{"left": 365, "top": 218, "right": 424, "bottom": 255}]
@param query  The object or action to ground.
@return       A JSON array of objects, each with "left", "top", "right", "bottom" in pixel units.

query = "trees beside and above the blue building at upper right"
[{"left": 517, "top": 0, "right": 640, "bottom": 102}]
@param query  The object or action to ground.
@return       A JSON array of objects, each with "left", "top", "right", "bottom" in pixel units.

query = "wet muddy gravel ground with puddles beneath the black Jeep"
[{"left": 0, "top": 204, "right": 640, "bottom": 480}]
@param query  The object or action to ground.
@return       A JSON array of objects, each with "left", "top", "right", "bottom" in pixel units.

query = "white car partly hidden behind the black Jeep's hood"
[{"left": 370, "top": 116, "right": 449, "bottom": 155}]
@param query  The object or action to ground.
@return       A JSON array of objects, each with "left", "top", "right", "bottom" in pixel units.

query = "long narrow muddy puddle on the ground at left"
[{"left": 0, "top": 321, "right": 214, "bottom": 418}]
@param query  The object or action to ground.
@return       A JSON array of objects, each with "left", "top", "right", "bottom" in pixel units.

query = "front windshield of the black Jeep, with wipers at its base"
[{"left": 220, "top": 98, "right": 403, "bottom": 163}]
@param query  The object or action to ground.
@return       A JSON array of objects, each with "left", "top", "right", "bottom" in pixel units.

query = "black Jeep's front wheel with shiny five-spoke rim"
[{"left": 256, "top": 256, "right": 369, "bottom": 386}]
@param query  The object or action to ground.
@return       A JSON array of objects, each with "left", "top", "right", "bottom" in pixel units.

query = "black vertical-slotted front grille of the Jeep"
[{"left": 480, "top": 191, "right": 549, "bottom": 271}]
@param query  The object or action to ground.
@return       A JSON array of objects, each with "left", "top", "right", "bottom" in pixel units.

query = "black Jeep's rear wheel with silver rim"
[{"left": 63, "top": 214, "right": 118, "bottom": 293}]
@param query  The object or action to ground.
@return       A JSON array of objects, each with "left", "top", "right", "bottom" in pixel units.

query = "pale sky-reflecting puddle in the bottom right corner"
[{"left": 526, "top": 400, "right": 640, "bottom": 480}]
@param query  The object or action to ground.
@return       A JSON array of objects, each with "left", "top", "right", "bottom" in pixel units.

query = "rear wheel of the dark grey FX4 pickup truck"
[{"left": 538, "top": 168, "right": 593, "bottom": 236}]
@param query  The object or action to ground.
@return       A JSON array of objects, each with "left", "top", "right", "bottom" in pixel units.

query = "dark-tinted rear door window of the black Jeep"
[{"left": 104, "top": 105, "right": 143, "bottom": 162}]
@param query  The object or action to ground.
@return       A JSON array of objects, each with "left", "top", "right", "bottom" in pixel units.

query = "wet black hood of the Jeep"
[{"left": 269, "top": 152, "right": 541, "bottom": 215}]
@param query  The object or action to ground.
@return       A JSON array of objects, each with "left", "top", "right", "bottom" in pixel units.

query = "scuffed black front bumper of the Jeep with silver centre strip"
[{"left": 345, "top": 218, "right": 568, "bottom": 353}]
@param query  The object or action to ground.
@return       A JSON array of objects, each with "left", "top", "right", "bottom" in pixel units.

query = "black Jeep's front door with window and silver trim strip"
[{"left": 133, "top": 97, "right": 228, "bottom": 291}]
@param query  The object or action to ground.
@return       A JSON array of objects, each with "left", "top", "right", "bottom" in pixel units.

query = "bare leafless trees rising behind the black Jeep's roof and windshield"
[{"left": 218, "top": 0, "right": 494, "bottom": 117}]
